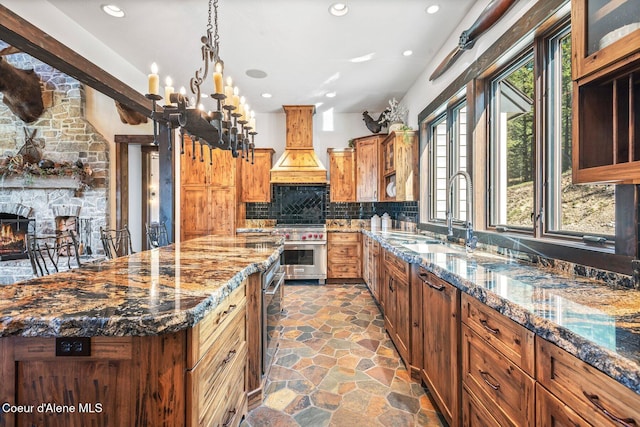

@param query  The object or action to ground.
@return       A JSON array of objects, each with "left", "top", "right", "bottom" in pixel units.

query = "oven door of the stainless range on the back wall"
[{"left": 280, "top": 242, "right": 327, "bottom": 281}]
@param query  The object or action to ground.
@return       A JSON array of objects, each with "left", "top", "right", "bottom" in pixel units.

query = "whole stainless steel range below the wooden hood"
[{"left": 276, "top": 224, "right": 327, "bottom": 284}]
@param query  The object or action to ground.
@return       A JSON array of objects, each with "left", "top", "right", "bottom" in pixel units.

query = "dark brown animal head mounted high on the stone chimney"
[{"left": 0, "top": 56, "right": 44, "bottom": 123}]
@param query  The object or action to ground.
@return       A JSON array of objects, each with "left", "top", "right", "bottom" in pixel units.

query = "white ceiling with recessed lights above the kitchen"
[{"left": 33, "top": 0, "right": 475, "bottom": 113}]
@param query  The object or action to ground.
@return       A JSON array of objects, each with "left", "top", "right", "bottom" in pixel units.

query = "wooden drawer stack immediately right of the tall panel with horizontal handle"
[{"left": 462, "top": 294, "right": 535, "bottom": 427}]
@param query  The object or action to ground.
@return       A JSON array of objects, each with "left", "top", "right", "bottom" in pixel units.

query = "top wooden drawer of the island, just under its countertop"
[{"left": 187, "top": 283, "right": 246, "bottom": 369}]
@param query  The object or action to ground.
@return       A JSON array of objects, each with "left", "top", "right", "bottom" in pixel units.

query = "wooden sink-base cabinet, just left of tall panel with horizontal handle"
[{"left": 383, "top": 251, "right": 411, "bottom": 366}]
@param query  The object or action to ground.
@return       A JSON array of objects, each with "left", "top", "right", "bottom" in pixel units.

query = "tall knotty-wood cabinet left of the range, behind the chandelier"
[{"left": 180, "top": 137, "right": 240, "bottom": 240}]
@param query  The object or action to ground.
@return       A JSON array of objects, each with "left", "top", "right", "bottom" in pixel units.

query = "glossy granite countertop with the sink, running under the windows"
[{"left": 363, "top": 230, "right": 640, "bottom": 394}]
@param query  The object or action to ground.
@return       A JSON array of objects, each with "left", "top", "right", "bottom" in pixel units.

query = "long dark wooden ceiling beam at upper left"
[{"left": 0, "top": 5, "right": 162, "bottom": 117}]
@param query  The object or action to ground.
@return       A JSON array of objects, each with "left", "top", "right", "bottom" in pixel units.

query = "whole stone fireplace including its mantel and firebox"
[{"left": 0, "top": 41, "right": 110, "bottom": 285}]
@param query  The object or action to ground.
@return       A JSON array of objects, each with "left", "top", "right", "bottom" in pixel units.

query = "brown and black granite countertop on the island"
[{"left": 0, "top": 235, "right": 283, "bottom": 337}]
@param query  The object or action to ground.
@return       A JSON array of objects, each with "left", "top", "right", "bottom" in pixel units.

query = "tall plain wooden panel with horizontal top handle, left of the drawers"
[{"left": 418, "top": 268, "right": 461, "bottom": 426}]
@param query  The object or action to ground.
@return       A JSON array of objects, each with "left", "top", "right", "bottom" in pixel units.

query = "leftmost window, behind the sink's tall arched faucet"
[{"left": 420, "top": 90, "right": 468, "bottom": 226}]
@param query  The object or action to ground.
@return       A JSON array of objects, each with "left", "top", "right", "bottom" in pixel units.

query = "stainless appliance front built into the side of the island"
[{"left": 262, "top": 269, "right": 284, "bottom": 375}]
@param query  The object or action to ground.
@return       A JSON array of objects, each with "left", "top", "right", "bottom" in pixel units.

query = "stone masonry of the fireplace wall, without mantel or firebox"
[{"left": 0, "top": 42, "right": 109, "bottom": 284}]
